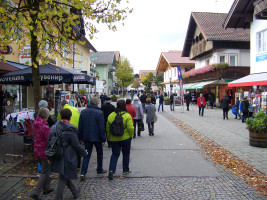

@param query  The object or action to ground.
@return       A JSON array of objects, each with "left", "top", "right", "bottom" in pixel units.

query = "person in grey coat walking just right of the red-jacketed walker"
[{"left": 145, "top": 98, "right": 156, "bottom": 136}]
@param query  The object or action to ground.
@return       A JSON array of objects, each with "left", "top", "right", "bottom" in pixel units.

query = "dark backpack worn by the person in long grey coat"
[{"left": 45, "top": 127, "right": 64, "bottom": 160}]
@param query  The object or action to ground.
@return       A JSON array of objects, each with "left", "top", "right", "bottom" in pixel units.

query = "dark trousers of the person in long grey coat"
[{"left": 55, "top": 174, "right": 78, "bottom": 200}]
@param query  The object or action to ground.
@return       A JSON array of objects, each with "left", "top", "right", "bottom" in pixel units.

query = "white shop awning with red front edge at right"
[{"left": 228, "top": 72, "right": 267, "bottom": 87}]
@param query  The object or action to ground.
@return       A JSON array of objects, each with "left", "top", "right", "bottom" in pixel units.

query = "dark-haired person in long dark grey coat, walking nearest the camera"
[{"left": 48, "top": 108, "right": 87, "bottom": 200}]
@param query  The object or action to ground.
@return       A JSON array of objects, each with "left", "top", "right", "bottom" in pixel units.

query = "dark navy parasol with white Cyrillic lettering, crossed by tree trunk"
[{"left": 0, "top": 64, "right": 95, "bottom": 85}]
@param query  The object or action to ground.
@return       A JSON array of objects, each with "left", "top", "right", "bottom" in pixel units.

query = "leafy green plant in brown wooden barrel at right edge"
[{"left": 246, "top": 110, "right": 267, "bottom": 148}]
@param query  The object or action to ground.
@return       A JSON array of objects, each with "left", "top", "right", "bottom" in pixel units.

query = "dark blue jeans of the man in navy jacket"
[{"left": 81, "top": 142, "right": 103, "bottom": 175}]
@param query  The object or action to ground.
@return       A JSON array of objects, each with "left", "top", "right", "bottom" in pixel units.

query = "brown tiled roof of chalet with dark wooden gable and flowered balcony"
[{"left": 182, "top": 12, "right": 250, "bottom": 56}]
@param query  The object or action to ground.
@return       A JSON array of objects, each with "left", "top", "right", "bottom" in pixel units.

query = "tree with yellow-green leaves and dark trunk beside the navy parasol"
[{"left": 0, "top": 0, "right": 132, "bottom": 108}]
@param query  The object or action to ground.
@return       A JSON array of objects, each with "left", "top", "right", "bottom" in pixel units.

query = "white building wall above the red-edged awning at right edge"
[{"left": 250, "top": 18, "right": 267, "bottom": 74}]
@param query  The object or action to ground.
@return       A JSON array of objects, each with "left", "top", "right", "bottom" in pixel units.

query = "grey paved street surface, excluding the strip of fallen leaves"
[{"left": 0, "top": 97, "right": 267, "bottom": 200}]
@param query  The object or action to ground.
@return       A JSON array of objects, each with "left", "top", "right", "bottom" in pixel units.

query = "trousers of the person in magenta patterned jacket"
[{"left": 32, "top": 158, "right": 50, "bottom": 196}]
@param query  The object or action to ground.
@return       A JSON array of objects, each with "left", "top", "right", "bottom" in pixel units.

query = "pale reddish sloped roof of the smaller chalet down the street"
[{"left": 162, "top": 50, "right": 195, "bottom": 64}]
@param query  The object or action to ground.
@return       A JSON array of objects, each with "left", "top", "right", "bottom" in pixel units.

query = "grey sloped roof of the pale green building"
[{"left": 90, "top": 51, "right": 116, "bottom": 65}]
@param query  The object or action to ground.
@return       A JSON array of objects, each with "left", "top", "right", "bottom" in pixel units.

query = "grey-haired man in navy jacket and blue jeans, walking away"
[{"left": 78, "top": 97, "right": 107, "bottom": 180}]
